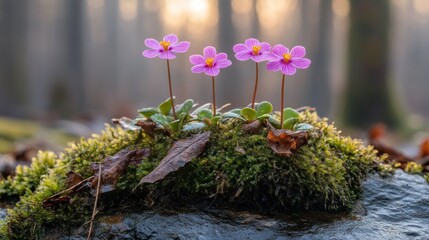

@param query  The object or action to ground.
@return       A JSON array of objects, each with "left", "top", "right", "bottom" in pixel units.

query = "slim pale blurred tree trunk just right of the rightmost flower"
[{"left": 304, "top": 0, "right": 332, "bottom": 116}]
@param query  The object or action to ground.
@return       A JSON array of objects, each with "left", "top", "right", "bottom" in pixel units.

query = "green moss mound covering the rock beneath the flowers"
[{"left": 0, "top": 112, "right": 381, "bottom": 239}]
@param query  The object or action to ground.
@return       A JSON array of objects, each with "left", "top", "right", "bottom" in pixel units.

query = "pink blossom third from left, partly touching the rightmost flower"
[{"left": 232, "top": 38, "right": 271, "bottom": 62}]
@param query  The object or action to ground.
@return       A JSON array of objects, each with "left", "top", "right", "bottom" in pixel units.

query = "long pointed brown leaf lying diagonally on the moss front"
[{"left": 139, "top": 132, "right": 210, "bottom": 185}]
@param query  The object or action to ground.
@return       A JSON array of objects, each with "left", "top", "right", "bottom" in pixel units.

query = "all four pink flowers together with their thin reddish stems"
[{"left": 143, "top": 34, "right": 311, "bottom": 124}]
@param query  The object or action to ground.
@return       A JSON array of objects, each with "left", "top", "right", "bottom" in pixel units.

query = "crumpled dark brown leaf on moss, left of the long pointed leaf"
[{"left": 91, "top": 148, "right": 150, "bottom": 193}]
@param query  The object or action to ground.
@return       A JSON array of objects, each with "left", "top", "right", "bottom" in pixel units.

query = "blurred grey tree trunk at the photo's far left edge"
[{"left": 0, "top": 0, "right": 28, "bottom": 116}]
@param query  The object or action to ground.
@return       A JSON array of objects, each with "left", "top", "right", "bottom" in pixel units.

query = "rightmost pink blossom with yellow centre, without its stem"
[{"left": 267, "top": 44, "right": 311, "bottom": 75}]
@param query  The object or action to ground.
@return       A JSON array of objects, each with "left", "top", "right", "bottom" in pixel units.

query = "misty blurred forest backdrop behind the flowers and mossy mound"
[{"left": 0, "top": 0, "right": 429, "bottom": 131}]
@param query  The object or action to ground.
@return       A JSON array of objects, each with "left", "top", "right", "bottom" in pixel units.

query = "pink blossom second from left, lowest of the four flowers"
[{"left": 189, "top": 46, "right": 232, "bottom": 77}]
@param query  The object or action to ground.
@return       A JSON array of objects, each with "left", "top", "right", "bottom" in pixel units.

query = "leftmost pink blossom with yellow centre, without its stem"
[{"left": 142, "top": 34, "right": 191, "bottom": 59}]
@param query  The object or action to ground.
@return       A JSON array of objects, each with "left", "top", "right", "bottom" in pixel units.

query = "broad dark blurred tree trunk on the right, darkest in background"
[{"left": 344, "top": 0, "right": 400, "bottom": 128}]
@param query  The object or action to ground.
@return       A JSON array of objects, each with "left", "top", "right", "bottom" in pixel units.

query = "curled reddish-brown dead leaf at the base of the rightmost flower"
[{"left": 267, "top": 124, "right": 308, "bottom": 157}]
